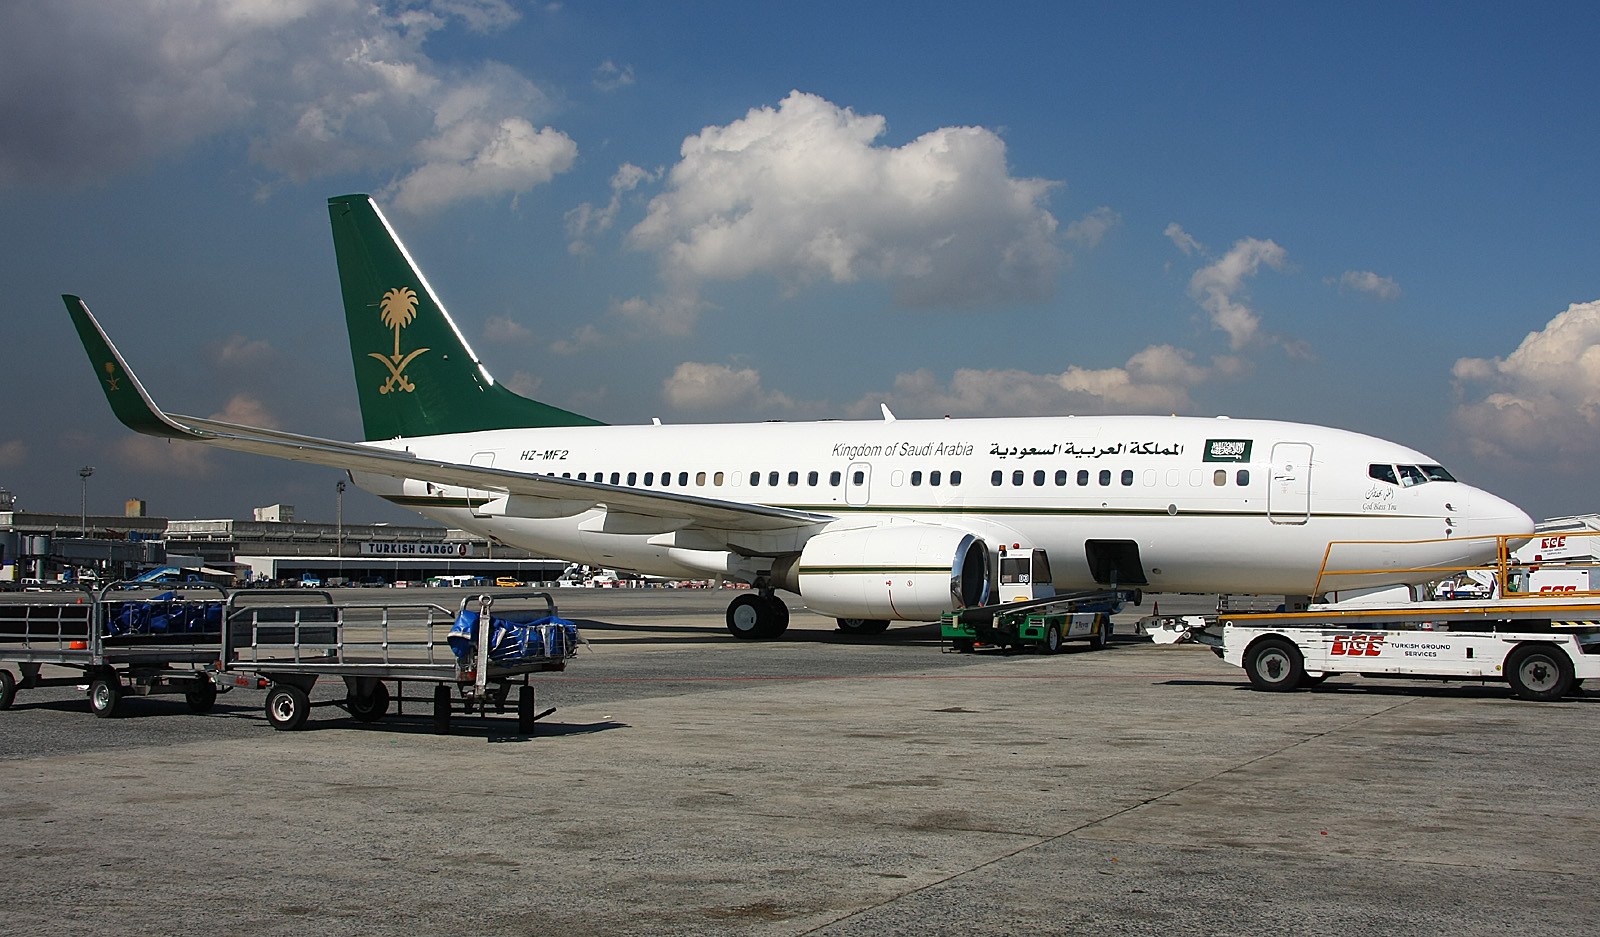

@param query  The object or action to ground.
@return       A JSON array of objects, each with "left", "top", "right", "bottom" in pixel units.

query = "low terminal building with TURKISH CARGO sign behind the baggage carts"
[{"left": 0, "top": 489, "right": 568, "bottom": 585}]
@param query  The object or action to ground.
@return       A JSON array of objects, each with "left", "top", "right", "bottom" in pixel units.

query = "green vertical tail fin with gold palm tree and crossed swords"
[{"left": 328, "top": 195, "right": 600, "bottom": 440}]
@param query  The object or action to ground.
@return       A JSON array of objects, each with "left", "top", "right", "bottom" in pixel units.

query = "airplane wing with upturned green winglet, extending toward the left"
[{"left": 62, "top": 296, "right": 835, "bottom": 531}]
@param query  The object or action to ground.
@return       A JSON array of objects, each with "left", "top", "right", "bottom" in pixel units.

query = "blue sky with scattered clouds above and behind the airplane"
[{"left": 0, "top": 0, "right": 1600, "bottom": 521}]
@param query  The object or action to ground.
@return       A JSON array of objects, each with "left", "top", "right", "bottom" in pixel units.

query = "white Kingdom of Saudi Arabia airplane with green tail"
[{"left": 64, "top": 195, "right": 1533, "bottom": 638}]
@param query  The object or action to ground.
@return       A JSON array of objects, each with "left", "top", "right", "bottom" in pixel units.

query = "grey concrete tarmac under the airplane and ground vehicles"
[{"left": 0, "top": 590, "right": 1600, "bottom": 937}]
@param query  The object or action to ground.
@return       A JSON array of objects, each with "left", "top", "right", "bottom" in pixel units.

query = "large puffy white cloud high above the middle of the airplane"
[{"left": 629, "top": 91, "right": 1062, "bottom": 305}]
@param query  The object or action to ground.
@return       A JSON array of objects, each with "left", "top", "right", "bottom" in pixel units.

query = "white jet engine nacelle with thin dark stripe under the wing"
[{"left": 773, "top": 524, "right": 989, "bottom": 622}]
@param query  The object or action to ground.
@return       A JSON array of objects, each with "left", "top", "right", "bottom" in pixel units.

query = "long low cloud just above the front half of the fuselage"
[{"left": 848, "top": 345, "right": 1228, "bottom": 417}]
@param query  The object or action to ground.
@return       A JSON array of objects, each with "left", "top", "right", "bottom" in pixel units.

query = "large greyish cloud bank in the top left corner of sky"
[{"left": 0, "top": 0, "right": 571, "bottom": 208}]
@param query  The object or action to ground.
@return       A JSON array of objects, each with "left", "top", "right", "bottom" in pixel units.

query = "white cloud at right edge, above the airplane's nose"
[{"left": 1451, "top": 301, "right": 1600, "bottom": 473}]
